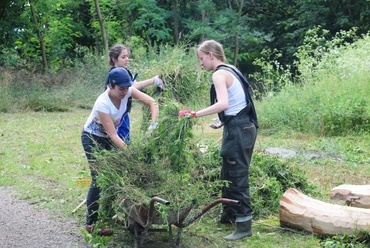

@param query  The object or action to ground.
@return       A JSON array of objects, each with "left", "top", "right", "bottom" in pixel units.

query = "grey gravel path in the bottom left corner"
[{"left": 0, "top": 187, "right": 88, "bottom": 248}]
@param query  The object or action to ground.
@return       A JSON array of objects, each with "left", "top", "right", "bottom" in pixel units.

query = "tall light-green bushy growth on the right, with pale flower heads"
[{"left": 259, "top": 32, "right": 370, "bottom": 135}]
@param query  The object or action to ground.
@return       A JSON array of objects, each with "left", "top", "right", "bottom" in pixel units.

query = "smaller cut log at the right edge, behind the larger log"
[{"left": 330, "top": 184, "right": 370, "bottom": 208}]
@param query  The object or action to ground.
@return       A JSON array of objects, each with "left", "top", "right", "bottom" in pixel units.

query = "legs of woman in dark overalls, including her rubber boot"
[{"left": 221, "top": 118, "right": 256, "bottom": 240}]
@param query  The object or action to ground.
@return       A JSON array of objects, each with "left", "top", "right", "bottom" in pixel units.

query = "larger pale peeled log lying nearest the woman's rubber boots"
[{"left": 280, "top": 188, "right": 370, "bottom": 236}]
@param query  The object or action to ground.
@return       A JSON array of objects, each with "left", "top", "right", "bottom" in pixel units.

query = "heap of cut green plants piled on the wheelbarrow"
[{"left": 97, "top": 103, "right": 222, "bottom": 226}]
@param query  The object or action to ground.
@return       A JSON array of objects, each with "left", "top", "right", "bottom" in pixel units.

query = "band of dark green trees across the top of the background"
[{"left": 0, "top": 0, "right": 370, "bottom": 73}]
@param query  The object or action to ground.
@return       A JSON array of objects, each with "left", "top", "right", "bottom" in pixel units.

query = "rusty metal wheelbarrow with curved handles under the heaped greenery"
[{"left": 121, "top": 197, "right": 240, "bottom": 248}]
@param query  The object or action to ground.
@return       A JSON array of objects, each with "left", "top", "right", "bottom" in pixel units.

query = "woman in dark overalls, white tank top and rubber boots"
[{"left": 179, "top": 40, "right": 258, "bottom": 240}]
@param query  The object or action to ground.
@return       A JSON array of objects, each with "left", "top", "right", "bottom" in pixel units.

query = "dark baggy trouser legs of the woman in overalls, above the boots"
[{"left": 220, "top": 113, "right": 257, "bottom": 218}]
